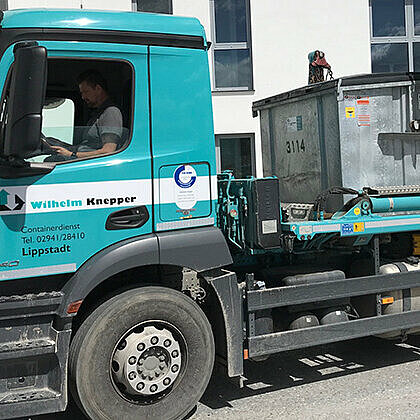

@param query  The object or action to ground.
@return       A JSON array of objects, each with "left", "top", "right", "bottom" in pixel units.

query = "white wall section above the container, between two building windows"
[{"left": 251, "top": 0, "right": 370, "bottom": 99}]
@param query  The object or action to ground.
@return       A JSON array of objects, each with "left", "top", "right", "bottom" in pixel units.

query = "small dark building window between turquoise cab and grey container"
[{"left": 216, "top": 134, "right": 255, "bottom": 178}]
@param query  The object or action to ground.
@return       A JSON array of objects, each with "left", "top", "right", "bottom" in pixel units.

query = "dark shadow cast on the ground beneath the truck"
[{"left": 32, "top": 336, "right": 420, "bottom": 420}]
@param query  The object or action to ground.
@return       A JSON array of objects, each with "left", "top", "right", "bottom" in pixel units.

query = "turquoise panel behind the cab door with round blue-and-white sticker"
[{"left": 150, "top": 46, "right": 217, "bottom": 231}]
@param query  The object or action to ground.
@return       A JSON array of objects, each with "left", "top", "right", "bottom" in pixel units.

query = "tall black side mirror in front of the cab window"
[{"left": 4, "top": 41, "right": 47, "bottom": 159}]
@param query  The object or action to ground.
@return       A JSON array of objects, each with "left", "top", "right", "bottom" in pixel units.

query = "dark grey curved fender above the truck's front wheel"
[{"left": 60, "top": 227, "right": 232, "bottom": 317}]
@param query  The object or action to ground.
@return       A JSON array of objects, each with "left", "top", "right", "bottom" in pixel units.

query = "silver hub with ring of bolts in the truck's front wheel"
[{"left": 112, "top": 326, "right": 182, "bottom": 396}]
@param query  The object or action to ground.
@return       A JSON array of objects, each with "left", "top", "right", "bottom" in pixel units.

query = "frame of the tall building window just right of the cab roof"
[{"left": 210, "top": 0, "right": 254, "bottom": 92}]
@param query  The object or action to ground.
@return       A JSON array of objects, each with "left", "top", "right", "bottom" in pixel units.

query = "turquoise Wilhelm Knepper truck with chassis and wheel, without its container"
[{"left": 0, "top": 9, "right": 420, "bottom": 420}]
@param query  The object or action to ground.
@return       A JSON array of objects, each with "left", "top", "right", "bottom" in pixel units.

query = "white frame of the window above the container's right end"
[{"left": 369, "top": 0, "right": 420, "bottom": 72}]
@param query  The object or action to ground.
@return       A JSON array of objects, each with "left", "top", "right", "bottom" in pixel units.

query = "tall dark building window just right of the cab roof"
[{"left": 210, "top": 0, "right": 253, "bottom": 90}]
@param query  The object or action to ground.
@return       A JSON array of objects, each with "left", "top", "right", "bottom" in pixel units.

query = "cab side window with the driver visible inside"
[{"left": 32, "top": 58, "right": 133, "bottom": 163}]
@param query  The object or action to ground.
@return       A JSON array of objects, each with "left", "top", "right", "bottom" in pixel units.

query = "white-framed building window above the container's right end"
[{"left": 369, "top": 0, "right": 420, "bottom": 73}]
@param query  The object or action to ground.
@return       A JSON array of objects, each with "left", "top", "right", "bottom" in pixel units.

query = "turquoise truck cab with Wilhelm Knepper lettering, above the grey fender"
[{"left": 0, "top": 10, "right": 216, "bottom": 280}]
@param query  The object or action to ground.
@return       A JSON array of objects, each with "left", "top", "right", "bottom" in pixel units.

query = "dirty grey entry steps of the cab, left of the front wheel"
[{"left": 0, "top": 292, "right": 71, "bottom": 419}]
